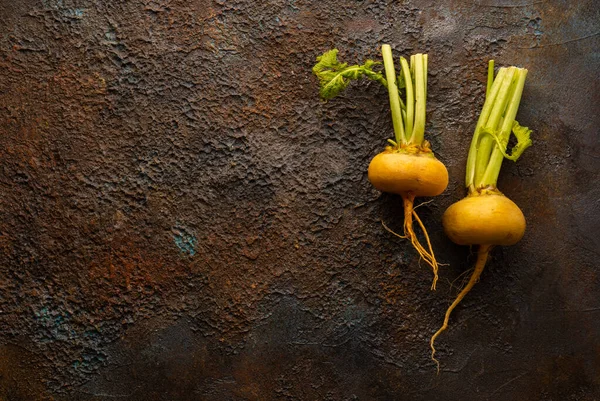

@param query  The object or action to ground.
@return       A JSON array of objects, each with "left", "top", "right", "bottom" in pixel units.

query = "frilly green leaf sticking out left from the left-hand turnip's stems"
[{"left": 313, "top": 49, "right": 387, "bottom": 100}]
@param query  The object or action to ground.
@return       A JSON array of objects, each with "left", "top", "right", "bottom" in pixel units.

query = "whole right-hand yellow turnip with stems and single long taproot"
[{"left": 430, "top": 60, "right": 531, "bottom": 371}]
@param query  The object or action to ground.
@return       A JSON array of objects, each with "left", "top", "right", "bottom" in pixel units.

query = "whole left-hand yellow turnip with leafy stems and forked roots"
[{"left": 313, "top": 45, "right": 448, "bottom": 289}]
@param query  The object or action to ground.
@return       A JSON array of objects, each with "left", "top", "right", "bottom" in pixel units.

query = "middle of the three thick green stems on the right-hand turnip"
[{"left": 475, "top": 67, "right": 516, "bottom": 187}]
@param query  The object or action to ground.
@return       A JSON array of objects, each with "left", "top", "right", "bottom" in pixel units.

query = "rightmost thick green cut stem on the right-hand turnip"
[{"left": 482, "top": 68, "right": 527, "bottom": 187}]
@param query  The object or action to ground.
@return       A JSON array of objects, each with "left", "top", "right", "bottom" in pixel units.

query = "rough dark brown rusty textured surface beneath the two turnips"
[{"left": 0, "top": 0, "right": 600, "bottom": 401}]
